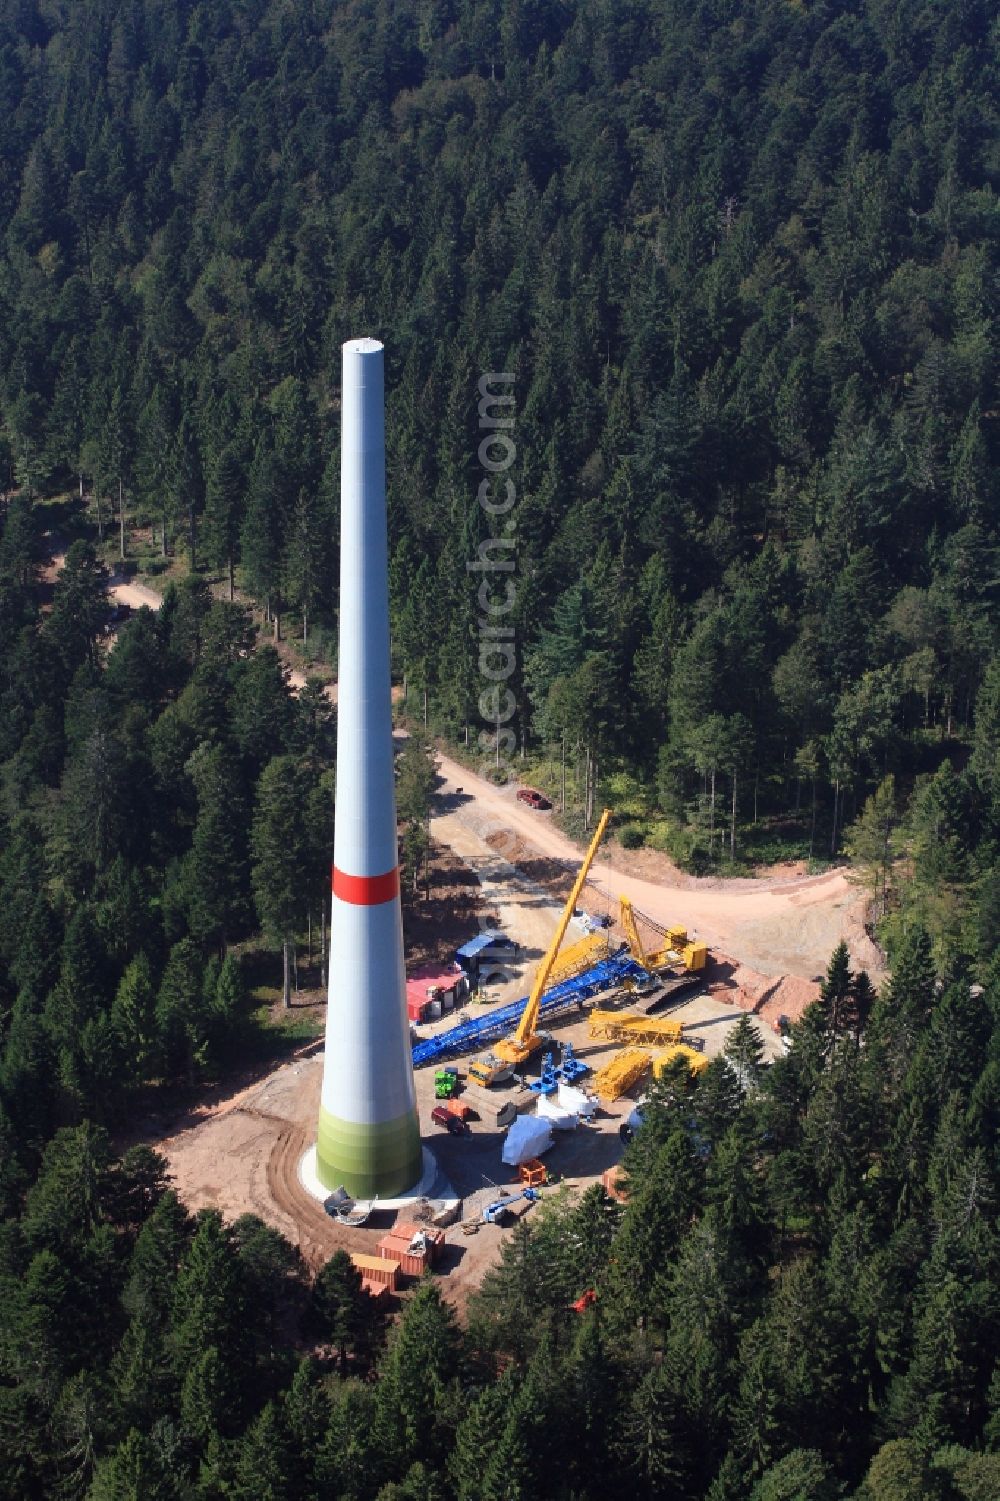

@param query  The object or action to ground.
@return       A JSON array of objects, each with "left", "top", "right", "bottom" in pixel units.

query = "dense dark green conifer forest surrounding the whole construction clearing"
[{"left": 0, "top": 0, "right": 1000, "bottom": 1501}]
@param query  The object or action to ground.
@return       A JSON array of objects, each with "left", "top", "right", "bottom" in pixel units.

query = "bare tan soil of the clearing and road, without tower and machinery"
[{"left": 134, "top": 720, "right": 863, "bottom": 1306}]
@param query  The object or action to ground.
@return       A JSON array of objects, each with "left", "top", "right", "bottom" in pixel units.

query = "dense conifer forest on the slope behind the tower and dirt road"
[{"left": 0, "top": 0, "right": 998, "bottom": 863}]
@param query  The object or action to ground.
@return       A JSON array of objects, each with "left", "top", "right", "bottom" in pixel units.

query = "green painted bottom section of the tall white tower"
[{"left": 315, "top": 1106, "right": 423, "bottom": 1199}]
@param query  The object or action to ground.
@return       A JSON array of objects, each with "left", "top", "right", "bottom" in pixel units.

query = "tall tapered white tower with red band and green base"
[{"left": 317, "top": 339, "right": 422, "bottom": 1198}]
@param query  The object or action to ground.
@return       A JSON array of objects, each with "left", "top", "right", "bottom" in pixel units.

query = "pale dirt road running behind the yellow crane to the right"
[{"left": 431, "top": 755, "right": 880, "bottom": 980}]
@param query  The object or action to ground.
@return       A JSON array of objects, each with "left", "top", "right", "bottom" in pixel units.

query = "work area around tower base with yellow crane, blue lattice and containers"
[{"left": 143, "top": 811, "right": 822, "bottom": 1306}]
